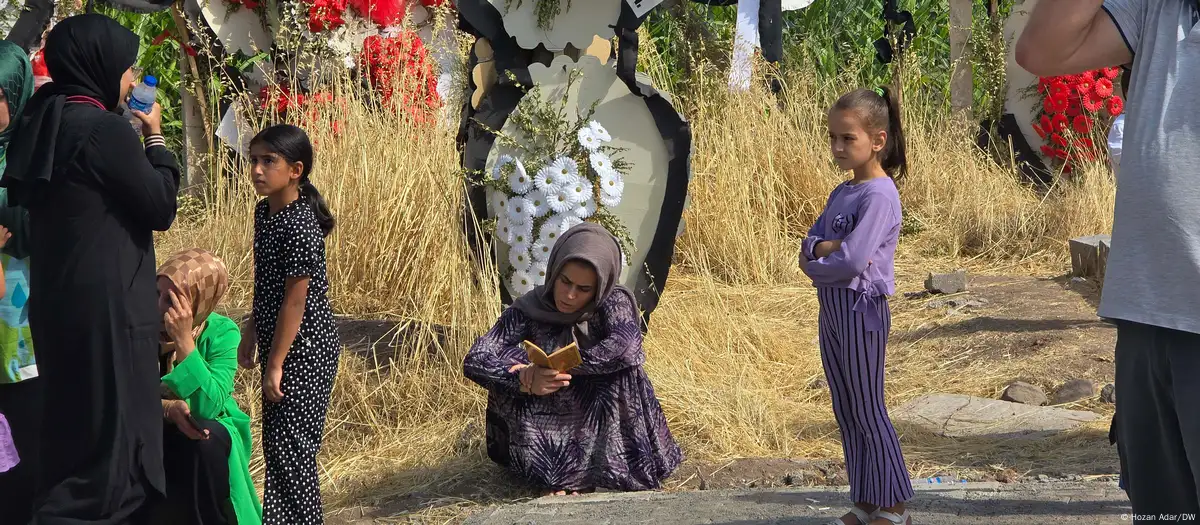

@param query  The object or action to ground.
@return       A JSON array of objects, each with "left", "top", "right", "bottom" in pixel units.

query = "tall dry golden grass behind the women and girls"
[{"left": 158, "top": 43, "right": 1114, "bottom": 517}]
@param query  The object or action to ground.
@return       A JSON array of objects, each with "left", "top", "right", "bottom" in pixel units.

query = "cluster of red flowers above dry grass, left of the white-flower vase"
[{"left": 359, "top": 30, "right": 440, "bottom": 122}]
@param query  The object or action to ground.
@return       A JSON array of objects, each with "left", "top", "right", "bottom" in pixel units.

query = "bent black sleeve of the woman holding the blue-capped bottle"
[{"left": 90, "top": 115, "right": 179, "bottom": 231}]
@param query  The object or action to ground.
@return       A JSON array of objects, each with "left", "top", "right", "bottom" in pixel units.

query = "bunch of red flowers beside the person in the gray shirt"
[{"left": 1033, "top": 67, "right": 1124, "bottom": 173}]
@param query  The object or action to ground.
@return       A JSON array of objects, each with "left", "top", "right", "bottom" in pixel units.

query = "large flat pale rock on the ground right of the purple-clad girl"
[{"left": 892, "top": 394, "right": 1100, "bottom": 439}]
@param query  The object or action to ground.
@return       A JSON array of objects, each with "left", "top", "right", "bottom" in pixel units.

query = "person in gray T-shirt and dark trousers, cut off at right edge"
[{"left": 1016, "top": 0, "right": 1200, "bottom": 515}]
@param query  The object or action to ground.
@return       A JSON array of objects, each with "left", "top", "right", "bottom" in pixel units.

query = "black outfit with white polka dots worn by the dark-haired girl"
[{"left": 253, "top": 199, "right": 341, "bottom": 525}]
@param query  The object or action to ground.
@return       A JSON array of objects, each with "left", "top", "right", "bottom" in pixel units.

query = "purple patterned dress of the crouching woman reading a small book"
[{"left": 463, "top": 294, "right": 683, "bottom": 490}]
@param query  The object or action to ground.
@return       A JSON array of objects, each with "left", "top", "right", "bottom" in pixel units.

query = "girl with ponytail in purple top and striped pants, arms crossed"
[{"left": 800, "top": 89, "right": 912, "bottom": 525}]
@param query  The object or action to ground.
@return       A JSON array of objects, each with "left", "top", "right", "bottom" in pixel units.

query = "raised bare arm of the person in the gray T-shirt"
[{"left": 1016, "top": 0, "right": 1128, "bottom": 77}]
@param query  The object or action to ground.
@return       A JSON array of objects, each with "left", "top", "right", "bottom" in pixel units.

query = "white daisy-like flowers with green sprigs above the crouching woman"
[{"left": 476, "top": 71, "right": 634, "bottom": 295}]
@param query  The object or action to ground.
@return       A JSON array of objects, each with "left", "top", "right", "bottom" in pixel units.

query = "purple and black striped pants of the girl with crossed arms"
[{"left": 817, "top": 288, "right": 912, "bottom": 507}]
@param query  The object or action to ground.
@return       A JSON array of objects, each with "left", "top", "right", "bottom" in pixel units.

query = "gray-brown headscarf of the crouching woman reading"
[{"left": 512, "top": 223, "right": 637, "bottom": 351}]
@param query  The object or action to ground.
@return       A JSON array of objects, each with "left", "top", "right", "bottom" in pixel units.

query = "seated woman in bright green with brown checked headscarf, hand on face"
[{"left": 150, "top": 248, "right": 263, "bottom": 525}]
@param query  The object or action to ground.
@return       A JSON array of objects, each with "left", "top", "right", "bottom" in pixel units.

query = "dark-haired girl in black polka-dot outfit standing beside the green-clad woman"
[{"left": 238, "top": 126, "right": 341, "bottom": 525}]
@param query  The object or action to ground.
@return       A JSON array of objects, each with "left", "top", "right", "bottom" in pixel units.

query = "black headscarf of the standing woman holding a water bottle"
[{"left": 0, "top": 14, "right": 139, "bottom": 203}]
